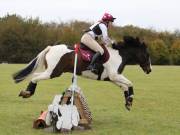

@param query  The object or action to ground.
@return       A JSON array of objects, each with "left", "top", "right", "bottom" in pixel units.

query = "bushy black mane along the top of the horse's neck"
[{"left": 112, "top": 36, "right": 146, "bottom": 50}]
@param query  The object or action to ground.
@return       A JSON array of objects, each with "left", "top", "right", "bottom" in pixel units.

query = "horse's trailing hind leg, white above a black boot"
[{"left": 19, "top": 70, "right": 51, "bottom": 98}]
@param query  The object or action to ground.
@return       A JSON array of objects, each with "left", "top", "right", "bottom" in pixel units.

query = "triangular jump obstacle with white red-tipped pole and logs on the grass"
[{"left": 33, "top": 44, "right": 92, "bottom": 132}]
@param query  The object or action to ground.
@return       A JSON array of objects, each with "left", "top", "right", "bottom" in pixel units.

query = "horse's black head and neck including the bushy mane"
[{"left": 113, "top": 36, "right": 151, "bottom": 74}]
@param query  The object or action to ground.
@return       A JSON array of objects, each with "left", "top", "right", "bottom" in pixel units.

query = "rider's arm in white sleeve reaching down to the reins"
[{"left": 99, "top": 24, "right": 111, "bottom": 45}]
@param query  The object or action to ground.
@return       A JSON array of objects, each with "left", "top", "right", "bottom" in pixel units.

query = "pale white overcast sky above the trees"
[{"left": 0, "top": 0, "right": 180, "bottom": 32}]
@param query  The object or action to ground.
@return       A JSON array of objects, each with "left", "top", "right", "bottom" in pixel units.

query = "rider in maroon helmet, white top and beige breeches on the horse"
[{"left": 81, "top": 13, "right": 116, "bottom": 72}]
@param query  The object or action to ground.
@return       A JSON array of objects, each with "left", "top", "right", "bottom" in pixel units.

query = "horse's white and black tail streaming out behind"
[{"left": 13, "top": 46, "right": 51, "bottom": 83}]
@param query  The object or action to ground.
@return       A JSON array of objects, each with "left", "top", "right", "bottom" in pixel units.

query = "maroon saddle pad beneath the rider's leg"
[{"left": 78, "top": 43, "right": 109, "bottom": 64}]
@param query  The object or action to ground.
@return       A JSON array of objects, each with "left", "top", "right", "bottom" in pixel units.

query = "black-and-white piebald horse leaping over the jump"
[{"left": 13, "top": 36, "right": 152, "bottom": 110}]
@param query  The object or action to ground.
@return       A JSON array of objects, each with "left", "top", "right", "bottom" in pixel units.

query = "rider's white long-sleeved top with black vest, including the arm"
[{"left": 88, "top": 22, "right": 111, "bottom": 45}]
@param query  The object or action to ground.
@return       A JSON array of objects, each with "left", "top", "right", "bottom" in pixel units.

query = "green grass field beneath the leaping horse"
[{"left": 0, "top": 64, "right": 180, "bottom": 135}]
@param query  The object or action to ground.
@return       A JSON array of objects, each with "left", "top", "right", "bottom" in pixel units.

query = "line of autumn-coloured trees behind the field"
[{"left": 0, "top": 15, "right": 180, "bottom": 65}]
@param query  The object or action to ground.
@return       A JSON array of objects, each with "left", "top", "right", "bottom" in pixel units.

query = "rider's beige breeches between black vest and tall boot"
[{"left": 81, "top": 33, "right": 104, "bottom": 55}]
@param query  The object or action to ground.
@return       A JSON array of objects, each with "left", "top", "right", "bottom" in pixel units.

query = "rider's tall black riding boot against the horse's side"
[{"left": 87, "top": 52, "right": 101, "bottom": 72}]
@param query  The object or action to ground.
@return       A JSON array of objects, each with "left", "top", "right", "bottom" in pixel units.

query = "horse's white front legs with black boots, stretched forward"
[{"left": 109, "top": 73, "right": 134, "bottom": 110}]
